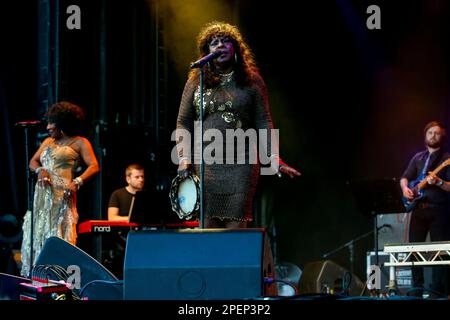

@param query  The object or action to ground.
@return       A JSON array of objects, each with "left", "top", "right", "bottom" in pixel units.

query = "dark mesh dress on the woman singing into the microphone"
[{"left": 177, "top": 73, "right": 272, "bottom": 221}]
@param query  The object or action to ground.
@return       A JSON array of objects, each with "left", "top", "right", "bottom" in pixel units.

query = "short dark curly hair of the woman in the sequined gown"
[{"left": 45, "top": 101, "right": 85, "bottom": 136}]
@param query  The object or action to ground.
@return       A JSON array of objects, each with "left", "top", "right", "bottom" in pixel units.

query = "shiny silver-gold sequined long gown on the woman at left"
[{"left": 21, "top": 141, "right": 79, "bottom": 276}]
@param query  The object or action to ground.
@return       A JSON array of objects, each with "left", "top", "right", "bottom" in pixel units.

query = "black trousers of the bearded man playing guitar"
[{"left": 409, "top": 206, "right": 450, "bottom": 294}]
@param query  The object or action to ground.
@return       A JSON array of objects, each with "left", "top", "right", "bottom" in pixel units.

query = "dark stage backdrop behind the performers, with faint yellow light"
[{"left": 0, "top": 0, "right": 450, "bottom": 279}]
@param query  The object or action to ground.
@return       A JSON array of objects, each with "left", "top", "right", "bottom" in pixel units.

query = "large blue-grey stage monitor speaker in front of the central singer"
[{"left": 124, "top": 229, "right": 276, "bottom": 300}]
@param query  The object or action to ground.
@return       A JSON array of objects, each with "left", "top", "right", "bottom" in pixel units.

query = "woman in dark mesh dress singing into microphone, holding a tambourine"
[{"left": 176, "top": 22, "right": 300, "bottom": 228}]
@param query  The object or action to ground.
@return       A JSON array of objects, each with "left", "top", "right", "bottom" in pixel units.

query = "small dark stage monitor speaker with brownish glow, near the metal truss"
[{"left": 298, "top": 260, "right": 365, "bottom": 296}]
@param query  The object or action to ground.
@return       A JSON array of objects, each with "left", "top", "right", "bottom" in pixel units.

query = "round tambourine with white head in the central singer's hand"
[{"left": 169, "top": 173, "right": 200, "bottom": 220}]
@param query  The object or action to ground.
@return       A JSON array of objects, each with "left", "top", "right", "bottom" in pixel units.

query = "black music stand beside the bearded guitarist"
[{"left": 348, "top": 178, "right": 406, "bottom": 265}]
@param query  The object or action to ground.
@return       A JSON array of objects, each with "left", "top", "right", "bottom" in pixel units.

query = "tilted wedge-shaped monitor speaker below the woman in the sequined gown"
[{"left": 36, "top": 237, "right": 123, "bottom": 300}]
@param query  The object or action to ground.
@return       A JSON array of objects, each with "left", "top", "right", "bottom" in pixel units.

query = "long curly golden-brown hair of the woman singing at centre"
[{"left": 189, "top": 21, "right": 259, "bottom": 87}]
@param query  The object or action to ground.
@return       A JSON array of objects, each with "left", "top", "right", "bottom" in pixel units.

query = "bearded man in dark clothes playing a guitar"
[{"left": 400, "top": 121, "right": 450, "bottom": 297}]
